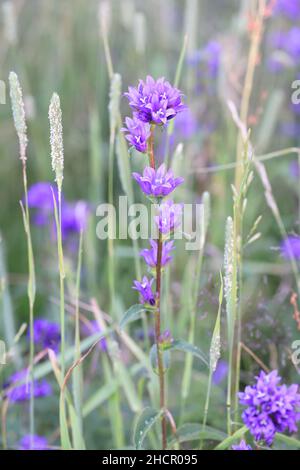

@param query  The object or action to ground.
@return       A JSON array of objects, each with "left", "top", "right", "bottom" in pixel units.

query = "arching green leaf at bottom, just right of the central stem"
[{"left": 169, "top": 423, "right": 226, "bottom": 446}]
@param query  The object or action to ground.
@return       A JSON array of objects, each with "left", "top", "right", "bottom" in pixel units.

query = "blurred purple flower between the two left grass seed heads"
[{"left": 28, "top": 181, "right": 58, "bottom": 225}]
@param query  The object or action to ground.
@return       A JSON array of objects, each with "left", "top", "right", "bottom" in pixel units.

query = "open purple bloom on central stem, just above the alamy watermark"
[{"left": 132, "top": 163, "right": 184, "bottom": 197}]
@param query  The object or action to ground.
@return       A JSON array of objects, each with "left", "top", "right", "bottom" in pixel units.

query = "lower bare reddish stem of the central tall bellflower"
[{"left": 155, "top": 233, "right": 167, "bottom": 449}]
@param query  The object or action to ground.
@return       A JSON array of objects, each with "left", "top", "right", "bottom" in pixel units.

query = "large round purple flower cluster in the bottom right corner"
[{"left": 239, "top": 370, "right": 300, "bottom": 446}]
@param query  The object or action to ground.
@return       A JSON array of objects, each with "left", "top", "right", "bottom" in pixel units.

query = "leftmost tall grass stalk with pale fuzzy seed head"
[{"left": 9, "top": 72, "right": 36, "bottom": 440}]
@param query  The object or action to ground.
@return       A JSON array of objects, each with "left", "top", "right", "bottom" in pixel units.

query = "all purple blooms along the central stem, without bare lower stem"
[{"left": 122, "top": 76, "right": 187, "bottom": 306}]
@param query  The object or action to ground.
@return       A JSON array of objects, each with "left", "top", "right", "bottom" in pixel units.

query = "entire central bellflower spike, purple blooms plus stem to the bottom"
[{"left": 122, "top": 76, "right": 187, "bottom": 449}]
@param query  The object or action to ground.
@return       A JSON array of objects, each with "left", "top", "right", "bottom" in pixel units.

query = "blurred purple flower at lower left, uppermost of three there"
[{"left": 28, "top": 318, "right": 60, "bottom": 352}]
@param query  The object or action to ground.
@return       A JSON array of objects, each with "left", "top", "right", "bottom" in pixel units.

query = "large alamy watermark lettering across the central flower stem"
[{"left": 96, "top": 196, "right": 205, "bottom": 251}]
